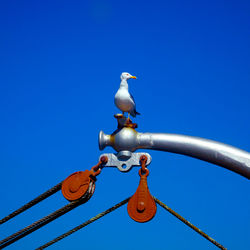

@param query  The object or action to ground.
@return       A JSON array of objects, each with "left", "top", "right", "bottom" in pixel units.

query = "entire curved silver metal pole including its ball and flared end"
[{"left": 99, "top": 128, "right": 250, "bottom": 179}]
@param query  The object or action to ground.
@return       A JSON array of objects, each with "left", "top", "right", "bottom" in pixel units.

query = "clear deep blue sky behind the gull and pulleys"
[{"left": 0, "top": 0, "right": 250, "bottom": 250}]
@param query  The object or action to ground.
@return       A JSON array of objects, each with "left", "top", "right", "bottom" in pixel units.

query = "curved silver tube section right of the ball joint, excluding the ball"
[{"left": 137, "top": 133, "right": 250, "bottom": 179}]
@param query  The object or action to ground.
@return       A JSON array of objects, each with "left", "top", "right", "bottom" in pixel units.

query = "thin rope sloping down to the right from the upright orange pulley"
[{"left": 153, "top": 197, "right": 226, "bottom": 250}]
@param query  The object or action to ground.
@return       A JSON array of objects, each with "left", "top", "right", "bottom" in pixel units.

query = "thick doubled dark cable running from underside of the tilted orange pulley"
[{"left": 0, "top": 186, "right": 92, "bottom": 249}]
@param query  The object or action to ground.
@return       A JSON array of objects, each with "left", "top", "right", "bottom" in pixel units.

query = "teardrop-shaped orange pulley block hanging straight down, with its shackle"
[{"left": 127, "top": 156, "right": 156, "bottom": 222}]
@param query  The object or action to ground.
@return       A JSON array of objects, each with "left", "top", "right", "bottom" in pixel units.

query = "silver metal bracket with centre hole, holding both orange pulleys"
[{"left": 99, "top": 151, "right": 152, "bottom": 172}]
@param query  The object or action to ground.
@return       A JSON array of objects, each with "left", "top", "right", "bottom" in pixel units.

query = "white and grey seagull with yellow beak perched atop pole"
[{"left": 115, "top": 72, "right": 140, "bottom": 118}]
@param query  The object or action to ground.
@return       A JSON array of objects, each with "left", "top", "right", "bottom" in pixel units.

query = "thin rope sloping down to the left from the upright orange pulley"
[{"left": 36, "top": 198, "right": 130, "bottom": 250}]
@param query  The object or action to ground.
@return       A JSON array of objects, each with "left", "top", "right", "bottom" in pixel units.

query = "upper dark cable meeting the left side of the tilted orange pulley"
[{"left": 0, "top": 182, "right": 62, "bottom": 225}]
